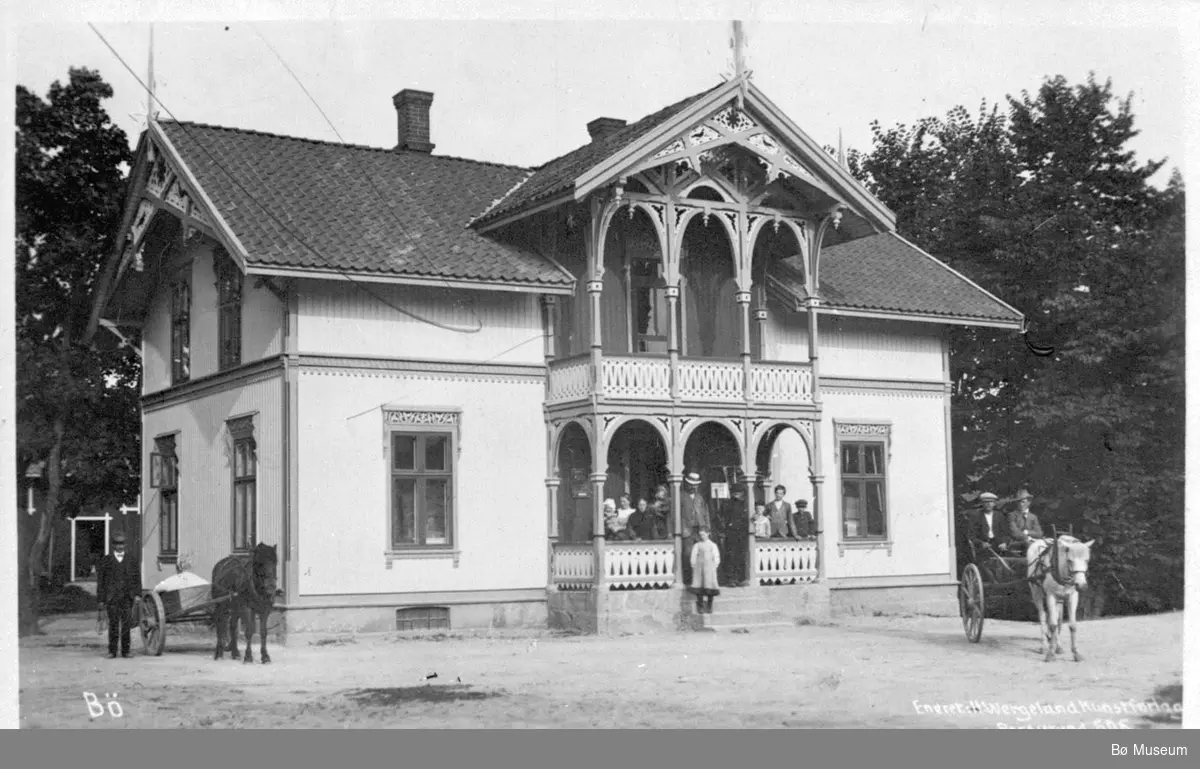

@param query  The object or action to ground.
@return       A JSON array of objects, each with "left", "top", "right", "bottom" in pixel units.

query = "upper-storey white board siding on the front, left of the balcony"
[{"left": 298, "top": 281, "right": 544, "bottom": 364}]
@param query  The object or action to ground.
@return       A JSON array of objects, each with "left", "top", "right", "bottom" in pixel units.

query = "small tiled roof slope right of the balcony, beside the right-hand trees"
[{"left": 773, "top": 233, "right": 1021, "bottom": 323}]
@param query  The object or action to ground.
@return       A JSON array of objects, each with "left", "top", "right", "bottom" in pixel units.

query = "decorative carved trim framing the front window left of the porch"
[{"left": 380, "top": 404, "right": 462, "bottom": 569}]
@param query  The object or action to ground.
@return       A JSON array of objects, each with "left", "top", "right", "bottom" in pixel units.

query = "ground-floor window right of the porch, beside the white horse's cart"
[{"left": 836, "top": 423, "right": 890, "bottom": 542}]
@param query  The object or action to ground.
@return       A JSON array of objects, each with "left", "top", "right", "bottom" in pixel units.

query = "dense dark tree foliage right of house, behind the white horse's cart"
[{"left": 850, "top": 71, "right": 1184, "bottom": 611}]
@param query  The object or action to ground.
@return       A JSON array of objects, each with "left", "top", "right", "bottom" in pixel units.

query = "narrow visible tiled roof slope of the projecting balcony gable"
[{"left": 475, "top": 83, "right": 725, "bottom": 224}]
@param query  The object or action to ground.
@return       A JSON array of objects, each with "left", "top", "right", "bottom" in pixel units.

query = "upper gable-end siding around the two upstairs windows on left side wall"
[{"left": 142, "top": 244, "right": 283, "bottom": 393}]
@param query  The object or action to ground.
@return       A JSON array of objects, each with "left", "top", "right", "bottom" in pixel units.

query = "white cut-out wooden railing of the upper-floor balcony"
[{"left": 546, "top": 355, "right": 812, "bottom": 404}]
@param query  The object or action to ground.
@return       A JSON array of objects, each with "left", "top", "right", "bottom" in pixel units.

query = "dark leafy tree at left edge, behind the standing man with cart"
[{"left": 16, "top": 68, "right": 140, "bottom": 633}]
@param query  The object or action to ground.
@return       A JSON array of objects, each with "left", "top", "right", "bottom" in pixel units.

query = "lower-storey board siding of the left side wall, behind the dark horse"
[{"left": 142, "top": 374, "right": 283, "bottom": 585}]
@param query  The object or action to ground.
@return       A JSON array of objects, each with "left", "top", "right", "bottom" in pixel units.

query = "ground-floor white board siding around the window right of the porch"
[{"left": 821, "top": 389, "right": 953, "bottom": 577}]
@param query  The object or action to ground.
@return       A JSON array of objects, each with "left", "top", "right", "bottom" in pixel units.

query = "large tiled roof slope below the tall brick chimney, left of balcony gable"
[{"left": 153, "top": 122, "right": 572, "bottom": 287}]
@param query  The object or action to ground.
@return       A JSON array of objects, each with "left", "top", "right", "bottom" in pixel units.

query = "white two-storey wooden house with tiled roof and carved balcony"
[{"left": 97, "top": 74, "right": 1022, "bottom": 632}]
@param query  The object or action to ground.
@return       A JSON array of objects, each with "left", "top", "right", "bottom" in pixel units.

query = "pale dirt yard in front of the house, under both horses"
[{"left": 20, "top": 613, "right": 1183, "bottom": 728}]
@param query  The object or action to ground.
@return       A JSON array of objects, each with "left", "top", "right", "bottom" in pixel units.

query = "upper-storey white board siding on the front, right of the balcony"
[{"left": 817, "top": 317, "right": 944, "bottom": 382}]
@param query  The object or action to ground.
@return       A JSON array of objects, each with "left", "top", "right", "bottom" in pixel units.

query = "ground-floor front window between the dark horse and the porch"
[{"left": 385, "top": 411, "right": 458, "bottom": 551}]
